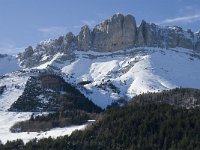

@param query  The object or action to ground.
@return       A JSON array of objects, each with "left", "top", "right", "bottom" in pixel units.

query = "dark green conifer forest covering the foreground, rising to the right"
[{"left": 1, "top": 89, "right": 200, "bottom": 150}]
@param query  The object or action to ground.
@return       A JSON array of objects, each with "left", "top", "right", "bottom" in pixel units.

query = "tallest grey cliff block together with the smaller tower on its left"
[{"left": 77, "top": 14, "right": 137, "bottom": 51}]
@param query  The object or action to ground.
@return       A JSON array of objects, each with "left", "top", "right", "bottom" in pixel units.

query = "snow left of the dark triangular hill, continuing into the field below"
[{"left": 0, "top": 69, "right": 92, "bottom": 143}]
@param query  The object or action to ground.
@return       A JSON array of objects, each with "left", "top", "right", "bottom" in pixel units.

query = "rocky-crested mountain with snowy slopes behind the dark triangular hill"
[{"left": 0, "top": 14, "right": 200, "bottom": 109}]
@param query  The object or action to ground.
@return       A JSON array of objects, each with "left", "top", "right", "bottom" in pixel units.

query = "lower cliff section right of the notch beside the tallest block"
[{"left": 137, "top": 21, "right": 194, "bottom": 49}]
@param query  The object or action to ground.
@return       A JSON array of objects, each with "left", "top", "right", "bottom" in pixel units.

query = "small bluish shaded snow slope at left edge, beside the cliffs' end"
[{"left": 0, "top": 54, "right": 20, "bottom": 76}]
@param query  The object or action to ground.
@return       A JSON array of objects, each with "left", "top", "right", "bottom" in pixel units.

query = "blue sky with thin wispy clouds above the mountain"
[{"left": 0, "top": 0, "right": 200, "bottom": 54}]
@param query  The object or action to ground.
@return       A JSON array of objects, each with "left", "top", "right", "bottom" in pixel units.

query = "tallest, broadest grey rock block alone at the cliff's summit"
[{"left": 92, "top": 14, "right": 137, "bottom": 51}]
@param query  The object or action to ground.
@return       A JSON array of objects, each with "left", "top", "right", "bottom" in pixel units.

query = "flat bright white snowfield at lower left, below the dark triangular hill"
[{"left": 0, "top": 112, "right": 87, "bottom": 143}]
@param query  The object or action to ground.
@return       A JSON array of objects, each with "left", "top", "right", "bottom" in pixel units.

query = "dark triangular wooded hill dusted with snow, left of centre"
[{"left": 9, "top": 73, "right": 101, "bottom": 113}]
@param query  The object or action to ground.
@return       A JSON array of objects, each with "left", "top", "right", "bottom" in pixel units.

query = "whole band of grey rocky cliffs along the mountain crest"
[{"left": 19, "top": 14, "right": 200, "bottom": 67}]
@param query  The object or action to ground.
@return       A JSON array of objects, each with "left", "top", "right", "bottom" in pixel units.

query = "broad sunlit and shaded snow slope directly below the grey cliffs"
[{"left": 32, "top": 48, "right": 200, "bottom": 107}]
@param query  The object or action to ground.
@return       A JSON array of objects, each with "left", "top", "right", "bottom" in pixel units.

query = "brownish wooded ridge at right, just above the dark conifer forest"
[{"left": 130, "top": 88, "right": 200, "bottom": 108}]
